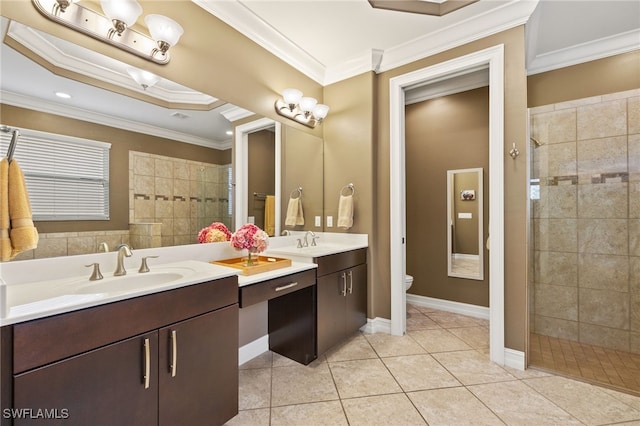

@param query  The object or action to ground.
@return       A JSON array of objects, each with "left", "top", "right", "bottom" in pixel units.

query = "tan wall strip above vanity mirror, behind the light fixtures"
[{"left": 1, "top": 0, "right": 322, "bottom": 135}]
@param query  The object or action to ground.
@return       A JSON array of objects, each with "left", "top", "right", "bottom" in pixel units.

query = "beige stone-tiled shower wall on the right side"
[{"left": 530, "top": 90, "right": 640, "bottom": 353}]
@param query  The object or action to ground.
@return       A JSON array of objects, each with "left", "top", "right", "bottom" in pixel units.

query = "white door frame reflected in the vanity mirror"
[{"left": 233, "top": 118, "right": 282, "bottom": 235}]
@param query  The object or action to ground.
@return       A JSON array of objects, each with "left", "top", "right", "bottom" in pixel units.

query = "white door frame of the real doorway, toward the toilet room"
[{"left": 389, "top": 44, "right": 505, "bottom": 365}]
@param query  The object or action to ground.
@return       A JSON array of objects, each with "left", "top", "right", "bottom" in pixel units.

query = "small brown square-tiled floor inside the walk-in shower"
[{"left": 529, "top": 333, "right": 640, "bottom": 396}]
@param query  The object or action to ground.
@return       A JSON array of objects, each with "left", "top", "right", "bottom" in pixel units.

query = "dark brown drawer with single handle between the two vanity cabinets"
[{"left": 240, "top": 269, "right": 316, "bottom": 308}]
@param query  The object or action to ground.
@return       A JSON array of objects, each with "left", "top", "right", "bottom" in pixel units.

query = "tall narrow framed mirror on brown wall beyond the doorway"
[{"left": 447, "top": 168, "right": 484, "bottom": 280}]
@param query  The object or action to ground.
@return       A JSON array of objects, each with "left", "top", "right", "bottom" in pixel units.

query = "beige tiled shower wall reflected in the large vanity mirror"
[{"left": 129, "top": 151, "right": 232, "bottom": 248}]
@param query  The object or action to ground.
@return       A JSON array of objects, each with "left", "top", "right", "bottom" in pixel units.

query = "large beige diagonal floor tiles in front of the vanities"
[{"left": 228, "top": 306, "right": 640, "bottom": 426}]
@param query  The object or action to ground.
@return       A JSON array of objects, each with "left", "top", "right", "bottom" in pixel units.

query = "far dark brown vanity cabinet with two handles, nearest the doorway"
[{"left": 315, "top": 249, "right": 367, "bottom": 354}]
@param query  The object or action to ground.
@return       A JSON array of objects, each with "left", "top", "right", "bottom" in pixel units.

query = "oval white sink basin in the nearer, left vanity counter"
[{"left": 74, "top": 272, "right": 184, "bottom": 294}]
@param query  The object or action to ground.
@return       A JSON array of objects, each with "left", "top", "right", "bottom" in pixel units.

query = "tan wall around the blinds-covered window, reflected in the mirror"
[{"left": 0, "top": 104, "right": 231, "bottom": 234}]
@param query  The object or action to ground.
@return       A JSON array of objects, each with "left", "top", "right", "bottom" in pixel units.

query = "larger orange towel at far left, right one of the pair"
[{"left": 9, "top": 160, "right": 38, "bottom": 258}]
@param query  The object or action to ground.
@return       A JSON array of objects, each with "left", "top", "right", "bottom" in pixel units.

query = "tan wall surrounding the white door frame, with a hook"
[{"left": 370, "top": 26, "right": 528, "bottom": 351}]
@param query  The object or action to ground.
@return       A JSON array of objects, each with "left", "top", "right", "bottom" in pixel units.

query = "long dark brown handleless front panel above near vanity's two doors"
[{"left": 13, "top": 276, "right": 238, "bottom": 373}]
